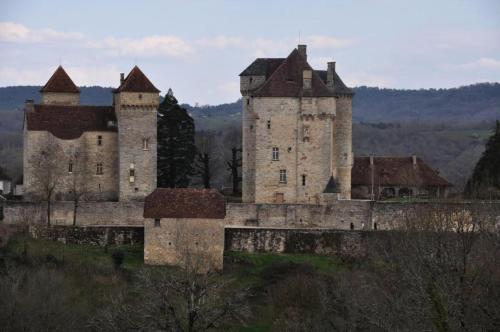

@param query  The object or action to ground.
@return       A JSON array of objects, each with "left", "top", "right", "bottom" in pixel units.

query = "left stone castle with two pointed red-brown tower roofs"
[{"left": 23, "top": 66, "right": 160, "bottom": 201}]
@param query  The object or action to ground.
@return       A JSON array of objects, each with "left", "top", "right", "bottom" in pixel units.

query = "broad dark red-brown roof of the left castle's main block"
[{"left": 26, "top": 105, "right": 117, "bottom": 139}]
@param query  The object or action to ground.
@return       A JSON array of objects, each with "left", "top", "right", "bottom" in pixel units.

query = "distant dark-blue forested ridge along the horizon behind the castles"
[{"left": 0, "top": 83, "right": 500, "bottom": 124}]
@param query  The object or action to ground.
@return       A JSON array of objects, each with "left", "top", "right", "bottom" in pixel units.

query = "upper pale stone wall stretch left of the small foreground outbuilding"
[{"left": 3, "top": 201, "right": 145, "bottom": 226}]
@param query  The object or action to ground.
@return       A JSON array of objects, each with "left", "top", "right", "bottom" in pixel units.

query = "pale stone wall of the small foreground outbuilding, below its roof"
[{"left": 144, "top": 218, "right": 224, "bottom": 271}]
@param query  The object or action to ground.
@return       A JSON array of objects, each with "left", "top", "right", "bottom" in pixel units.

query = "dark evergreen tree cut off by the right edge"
[{"left": 465, "top": 121, "right": 500, "bottom": 198}]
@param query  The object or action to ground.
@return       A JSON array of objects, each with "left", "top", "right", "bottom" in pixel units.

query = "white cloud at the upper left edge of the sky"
[{"left": 0, "top": 22, "right": 83, "bottom": 43}]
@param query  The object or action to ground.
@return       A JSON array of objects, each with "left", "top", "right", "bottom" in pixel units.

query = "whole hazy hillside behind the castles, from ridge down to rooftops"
[{"left": 0, "top": 83, "right": 500, "bottom": 190}]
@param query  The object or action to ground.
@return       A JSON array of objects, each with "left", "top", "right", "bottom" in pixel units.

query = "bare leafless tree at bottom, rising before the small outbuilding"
[{"left": 92, "top": 221, "right": 246, "bottom": 332}]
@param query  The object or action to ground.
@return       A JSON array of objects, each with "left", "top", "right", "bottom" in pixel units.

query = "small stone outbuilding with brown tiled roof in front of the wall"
[{"left": 144, "top": 188, "right": 226, "bottom": 272}]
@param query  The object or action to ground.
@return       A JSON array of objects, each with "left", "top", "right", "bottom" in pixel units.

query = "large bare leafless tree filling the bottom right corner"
[{"left": 353, "top": 203, "right": 500, "bottom": 331}]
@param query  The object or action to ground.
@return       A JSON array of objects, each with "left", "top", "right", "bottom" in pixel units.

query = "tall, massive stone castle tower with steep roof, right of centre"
[{"left": 240, "top": 45, "right": 353, "bottom": 204}]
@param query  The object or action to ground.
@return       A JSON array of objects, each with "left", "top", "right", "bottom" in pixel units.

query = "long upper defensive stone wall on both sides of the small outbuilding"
[{"left": 0, "top": 200, "right": 500, "bottom": 230}]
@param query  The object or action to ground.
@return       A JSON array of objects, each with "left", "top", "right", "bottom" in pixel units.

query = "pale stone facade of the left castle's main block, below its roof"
[{"left": 23, "top": 130, "right": 118, "bottom": 200}]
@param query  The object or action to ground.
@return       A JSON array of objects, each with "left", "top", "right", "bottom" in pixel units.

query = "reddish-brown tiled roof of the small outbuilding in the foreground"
[{"left": 144, "top": 188, "right": 226, "bottom": 219}]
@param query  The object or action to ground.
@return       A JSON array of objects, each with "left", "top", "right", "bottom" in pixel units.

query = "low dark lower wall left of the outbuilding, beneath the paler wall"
[{"left": 29, "top": 225, "right": 144, "bottom": 247}]
